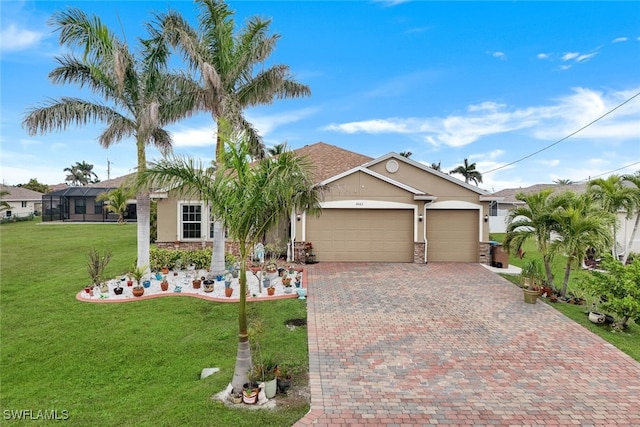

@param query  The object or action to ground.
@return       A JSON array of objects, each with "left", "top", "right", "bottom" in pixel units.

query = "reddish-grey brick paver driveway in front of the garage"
[{"left": 296, "top": 263, "right": 640, "bottom": 426}]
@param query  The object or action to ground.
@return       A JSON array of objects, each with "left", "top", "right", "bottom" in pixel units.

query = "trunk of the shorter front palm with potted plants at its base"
[{"left": 231, "top": 246, "right": 253, "bottom": 393}]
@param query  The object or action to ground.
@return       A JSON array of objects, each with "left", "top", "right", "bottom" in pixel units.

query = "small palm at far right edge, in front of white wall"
[{"left": 587, "top": 175, "right": 635, "bottom": 259}]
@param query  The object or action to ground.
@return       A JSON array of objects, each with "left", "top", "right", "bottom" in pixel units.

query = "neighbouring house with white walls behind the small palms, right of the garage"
[{"left": 489, "top": 183, "right": 640, "bottom": 253}]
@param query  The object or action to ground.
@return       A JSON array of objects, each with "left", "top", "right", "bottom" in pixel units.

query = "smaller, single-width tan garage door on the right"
[{"left": 426, "top": 209, "right": 479, "bottom": 262}]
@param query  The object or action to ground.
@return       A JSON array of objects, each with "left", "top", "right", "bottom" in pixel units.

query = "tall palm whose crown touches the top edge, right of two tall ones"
[{"left": 152, "top": 0, "right": 311, "bottom": 274}]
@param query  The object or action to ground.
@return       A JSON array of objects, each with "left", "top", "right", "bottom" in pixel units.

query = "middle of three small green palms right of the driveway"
[{"left": 550, "top": 192, "right": 615, "bottom": 296}]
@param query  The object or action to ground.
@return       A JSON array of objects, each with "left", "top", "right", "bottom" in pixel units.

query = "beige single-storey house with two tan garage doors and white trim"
[{"left": 157, "top": 142, "right": 497, "bottom": 264}]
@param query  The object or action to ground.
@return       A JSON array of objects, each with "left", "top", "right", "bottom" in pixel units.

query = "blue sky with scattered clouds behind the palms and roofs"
[{"left": 0, "top": 1, "right": 640, "bottom": 191}]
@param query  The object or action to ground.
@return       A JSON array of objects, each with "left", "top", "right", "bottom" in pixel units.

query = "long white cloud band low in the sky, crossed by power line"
[{"left": 324, "top": 88, "right": 640, "bottom": 147}]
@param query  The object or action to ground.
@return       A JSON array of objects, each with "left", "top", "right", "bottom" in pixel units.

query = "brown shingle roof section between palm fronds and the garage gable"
[{"left": 294, "top": 142, "right": 373, "bottom": 183}]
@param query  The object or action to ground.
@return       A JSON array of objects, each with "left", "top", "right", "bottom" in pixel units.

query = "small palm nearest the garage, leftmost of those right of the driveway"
[{"left": 504, "top": 188, "right": 560, "bottom": 288}]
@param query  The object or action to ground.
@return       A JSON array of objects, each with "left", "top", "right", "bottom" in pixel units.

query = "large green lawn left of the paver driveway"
[{"left": 0, "top": 220, "right": 309, "bottom": 426}]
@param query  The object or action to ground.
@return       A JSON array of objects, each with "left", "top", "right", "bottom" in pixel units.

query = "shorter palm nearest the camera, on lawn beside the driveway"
[{"left": 143, "top": 130, "right": 321, "bottom": 391}]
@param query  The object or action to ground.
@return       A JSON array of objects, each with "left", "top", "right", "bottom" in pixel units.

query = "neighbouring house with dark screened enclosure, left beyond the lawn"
[{"left": 41, "top": 173, "right": 137, "bottom": 222}]
